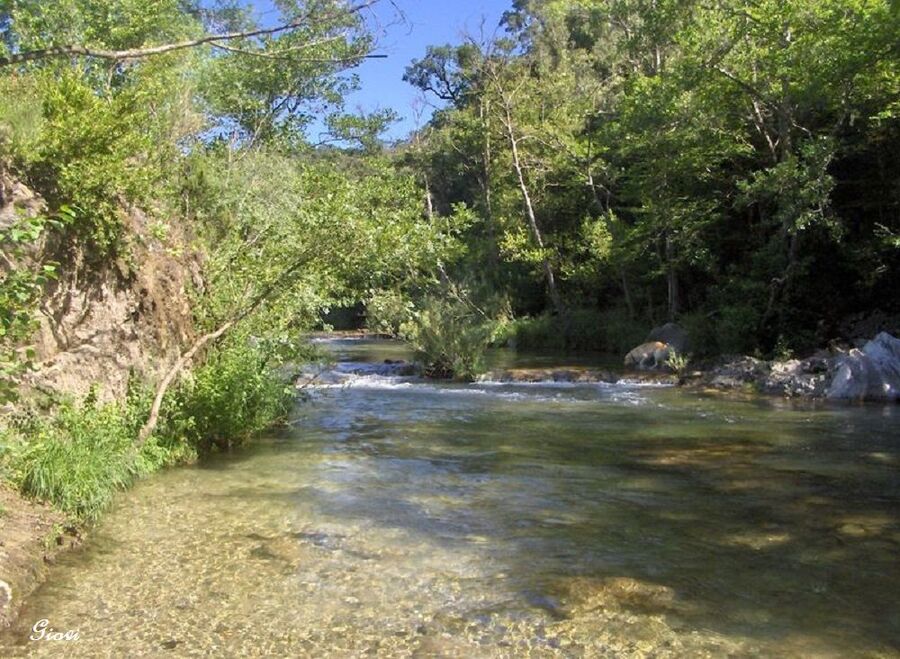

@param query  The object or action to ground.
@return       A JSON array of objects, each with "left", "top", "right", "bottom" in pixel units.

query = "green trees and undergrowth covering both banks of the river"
[{"left": 0, "top": 0, "right": 900, "bottom": 516}]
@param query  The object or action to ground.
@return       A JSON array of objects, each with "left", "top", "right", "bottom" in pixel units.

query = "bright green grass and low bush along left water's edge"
[{"left": 6, "top": 343, "right": 292, "bottom": 521}]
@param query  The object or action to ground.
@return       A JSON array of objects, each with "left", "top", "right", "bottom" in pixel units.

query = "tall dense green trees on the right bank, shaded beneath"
[{"left": 406, "top": 0, "right": 900, "bottom": 352}]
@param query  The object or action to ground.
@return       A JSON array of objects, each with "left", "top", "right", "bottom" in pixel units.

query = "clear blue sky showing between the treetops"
[{"left": 253, "top": 0, "right": 512, "bottom": 140}]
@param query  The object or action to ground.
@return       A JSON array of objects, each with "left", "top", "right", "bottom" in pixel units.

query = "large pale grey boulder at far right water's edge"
[{"left": 827, "top": 332, "right": 900, "bottom": 402}]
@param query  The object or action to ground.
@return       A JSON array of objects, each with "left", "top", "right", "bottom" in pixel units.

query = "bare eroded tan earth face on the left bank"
[{"left": 0, "top": 169, "right": 203, "bottom": 399}]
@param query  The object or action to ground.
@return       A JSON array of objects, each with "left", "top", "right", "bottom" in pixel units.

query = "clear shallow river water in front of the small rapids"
[{"left": 0, "top": 342, "right": 900, "bottom": 657}]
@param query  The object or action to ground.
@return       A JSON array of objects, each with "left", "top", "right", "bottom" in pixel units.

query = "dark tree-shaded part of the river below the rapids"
[{"left": 304, "top": 384, "right": 900, "bottom": 651}]
